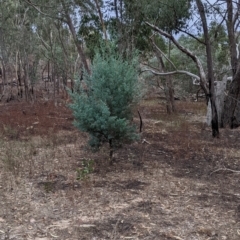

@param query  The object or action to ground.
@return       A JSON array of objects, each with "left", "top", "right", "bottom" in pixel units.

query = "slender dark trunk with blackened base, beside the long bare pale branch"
[{"left": 196, "top": 0, "right": 219, "bottom": 137}]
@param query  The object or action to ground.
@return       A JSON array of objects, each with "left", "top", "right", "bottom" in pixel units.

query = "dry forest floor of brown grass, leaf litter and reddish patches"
[{"left": 0, "top": 100, "right": 240, "bottom": 240}]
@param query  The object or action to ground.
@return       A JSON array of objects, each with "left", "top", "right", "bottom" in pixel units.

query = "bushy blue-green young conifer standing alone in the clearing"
[{"left": 70, "top": 49, "right": 141, "bottom": 163}]
